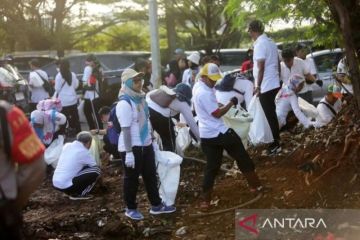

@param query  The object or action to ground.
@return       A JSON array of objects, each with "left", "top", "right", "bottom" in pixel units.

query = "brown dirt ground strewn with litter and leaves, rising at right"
[{"left": 24, "top": 100, "right": 360, "bottom": 239}]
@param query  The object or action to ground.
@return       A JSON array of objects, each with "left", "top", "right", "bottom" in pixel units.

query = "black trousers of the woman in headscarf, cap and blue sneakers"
[{"left": 120, "top": 145, "right": 161, "bottom": 209}]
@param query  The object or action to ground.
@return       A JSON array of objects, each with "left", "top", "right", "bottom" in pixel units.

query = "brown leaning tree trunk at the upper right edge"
[{"left": 330, "top": 0, "right": 360, "bottom": 110}]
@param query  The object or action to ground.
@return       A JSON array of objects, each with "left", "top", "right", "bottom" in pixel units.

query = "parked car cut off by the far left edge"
[{"left": 0, "top": 62, "right": 30, "bottom": 113}]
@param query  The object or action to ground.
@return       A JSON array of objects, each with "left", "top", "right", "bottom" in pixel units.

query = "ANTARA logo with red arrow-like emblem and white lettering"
[{"left": 238, "top": 214, "right": 327, "bottom": 235}]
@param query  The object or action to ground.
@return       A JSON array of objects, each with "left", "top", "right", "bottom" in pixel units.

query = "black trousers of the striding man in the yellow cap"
[{"left": 201, "top": 128, "right": 255, "bottom": 193}]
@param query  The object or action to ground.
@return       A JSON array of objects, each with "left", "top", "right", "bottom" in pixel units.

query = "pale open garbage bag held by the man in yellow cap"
[{"left": 223, "top": 108, "right": 253, "bottom": 149}]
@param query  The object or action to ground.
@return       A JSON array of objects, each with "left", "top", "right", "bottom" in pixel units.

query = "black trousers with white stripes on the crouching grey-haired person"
[{"left": 57, "top": 166, "right": 100, "bottom": 196}]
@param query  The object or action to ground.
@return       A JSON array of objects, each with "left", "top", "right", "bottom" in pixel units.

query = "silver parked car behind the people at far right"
[{"left": 306, "top": 48, "right": 344, "bottom": 104}]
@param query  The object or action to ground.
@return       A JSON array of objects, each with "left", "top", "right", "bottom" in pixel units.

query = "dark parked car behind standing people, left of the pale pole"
[{"left": 42, "top": 51, "right": 151, "bottom": 105}]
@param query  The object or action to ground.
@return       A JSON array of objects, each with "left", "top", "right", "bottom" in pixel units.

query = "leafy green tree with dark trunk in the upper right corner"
[{"left": 226, "top": 0, "right": 360, "bottom": 110}]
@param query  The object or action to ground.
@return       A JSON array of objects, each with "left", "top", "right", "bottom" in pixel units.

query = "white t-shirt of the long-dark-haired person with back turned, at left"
[{"left": 55, "top": 72, "right": 79, "bottom": 107}]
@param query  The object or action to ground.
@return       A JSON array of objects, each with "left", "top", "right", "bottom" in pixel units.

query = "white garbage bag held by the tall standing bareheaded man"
[{"left": 249, "top": 96, "right": 274, "bottom": 145}]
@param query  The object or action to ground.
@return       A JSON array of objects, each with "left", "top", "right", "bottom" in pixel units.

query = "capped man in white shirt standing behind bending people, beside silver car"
[{"left": 296, "top": 43, "right": 322, "bottom": 104}]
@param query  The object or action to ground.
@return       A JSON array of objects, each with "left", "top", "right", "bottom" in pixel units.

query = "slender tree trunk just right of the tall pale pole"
[{"left": 165, "top": 0, "right": 177, "bottom": 60}]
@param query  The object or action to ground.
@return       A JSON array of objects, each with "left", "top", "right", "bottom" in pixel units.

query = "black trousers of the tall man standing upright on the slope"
[{"left": 259, "top": 88, "right": 280, "bottom": 143}]
